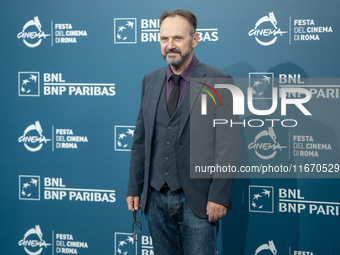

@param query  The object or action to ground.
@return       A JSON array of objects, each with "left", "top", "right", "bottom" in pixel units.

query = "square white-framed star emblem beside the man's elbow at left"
[{"left": 114, "top": 126, "right": 135, "bottom": 151}]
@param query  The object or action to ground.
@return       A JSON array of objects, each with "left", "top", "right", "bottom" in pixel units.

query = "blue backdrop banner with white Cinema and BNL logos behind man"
[{"left": 0, "top": 0, "right": 340, "bottom": 255}]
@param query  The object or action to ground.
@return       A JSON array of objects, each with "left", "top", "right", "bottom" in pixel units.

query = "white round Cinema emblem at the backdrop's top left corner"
[{"left": 17, "top": 16, "right": 51, "bottom": 48}]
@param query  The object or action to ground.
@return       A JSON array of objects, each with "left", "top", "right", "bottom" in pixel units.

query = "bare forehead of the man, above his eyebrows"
[{"left": 159, "top": 15, "right": 191, "bottom": 36}]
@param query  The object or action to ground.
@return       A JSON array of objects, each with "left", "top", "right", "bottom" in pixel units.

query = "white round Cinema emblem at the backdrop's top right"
[{"left": 248, "top": 12, "right": 288, "bottom": 46}]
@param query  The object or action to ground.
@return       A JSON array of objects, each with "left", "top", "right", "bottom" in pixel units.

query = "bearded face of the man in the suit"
[{"left": 159, "top": 16, "right": 198, "bottom": 68}]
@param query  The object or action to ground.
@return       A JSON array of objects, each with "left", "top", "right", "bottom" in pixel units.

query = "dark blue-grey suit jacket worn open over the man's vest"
[{"left": 127, "top": 60, "right": 239, "bottom": 218}]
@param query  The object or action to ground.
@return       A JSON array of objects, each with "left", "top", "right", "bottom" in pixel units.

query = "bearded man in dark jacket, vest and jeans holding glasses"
[{"left": 126, "top": 10, "right": 238, "bottom": 255}]
